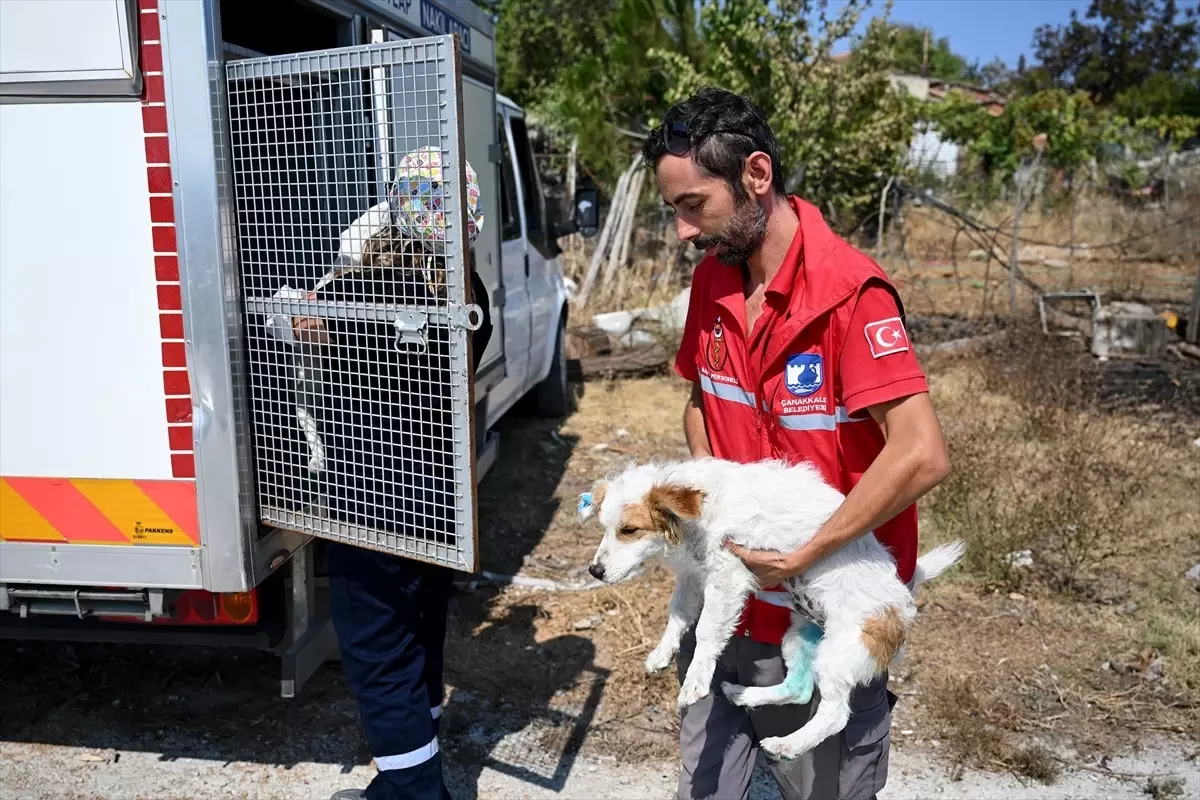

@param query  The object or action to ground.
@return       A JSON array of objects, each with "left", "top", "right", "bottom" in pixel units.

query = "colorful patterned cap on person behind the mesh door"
[{"left": 388, "top": 148, "right": 484, "bottom": 253}]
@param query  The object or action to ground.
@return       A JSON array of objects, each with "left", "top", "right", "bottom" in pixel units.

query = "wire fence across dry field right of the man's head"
[{"left": 868, "top": 167, "right": 1200, "bottom": 315}]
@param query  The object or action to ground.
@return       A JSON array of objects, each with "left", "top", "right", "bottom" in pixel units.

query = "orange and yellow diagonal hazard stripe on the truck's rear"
[{"left": 0, "top": 477, "right": 199, "bottom": 547}]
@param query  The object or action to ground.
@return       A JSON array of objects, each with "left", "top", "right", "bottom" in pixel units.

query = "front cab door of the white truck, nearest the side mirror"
[{"left": 509, "top": 110, "right": 559, "bottom": 389}]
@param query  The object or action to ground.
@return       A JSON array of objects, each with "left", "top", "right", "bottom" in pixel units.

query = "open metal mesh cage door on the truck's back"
[{"left": 226, "top": 36, "right": 482, "bottom": 570}]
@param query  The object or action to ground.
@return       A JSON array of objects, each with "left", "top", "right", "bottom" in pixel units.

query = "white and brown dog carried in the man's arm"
[{"left": 580, "top": 458, "right": 964, "bottom": 758}]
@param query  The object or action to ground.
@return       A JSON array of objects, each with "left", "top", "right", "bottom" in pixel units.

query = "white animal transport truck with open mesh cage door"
[{"left": 0, "top": 0, "right": 596, "bottom": 697}]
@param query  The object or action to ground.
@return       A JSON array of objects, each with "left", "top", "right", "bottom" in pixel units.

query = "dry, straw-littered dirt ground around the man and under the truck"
[{"left": 0, "top": 318, "right": 1200, "bottom": 798}]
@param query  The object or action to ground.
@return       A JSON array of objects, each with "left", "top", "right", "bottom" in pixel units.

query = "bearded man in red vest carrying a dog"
[{"left": 642, "top": 89, "right": 949, "bottom": 800}]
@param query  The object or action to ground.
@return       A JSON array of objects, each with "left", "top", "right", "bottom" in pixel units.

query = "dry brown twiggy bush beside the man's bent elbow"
[{"left": 928, "top": 327, "right": 1183, "bottom": 595}]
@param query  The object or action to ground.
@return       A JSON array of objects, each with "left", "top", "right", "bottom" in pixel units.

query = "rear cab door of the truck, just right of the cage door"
[{"left": 496, "top": 110, "right": 532, "bottom": 393}]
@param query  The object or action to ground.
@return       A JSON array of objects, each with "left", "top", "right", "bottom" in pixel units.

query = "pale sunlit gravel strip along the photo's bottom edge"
[{"left": 0, "top": 729, "right": 1200, "bottom": 800}]
